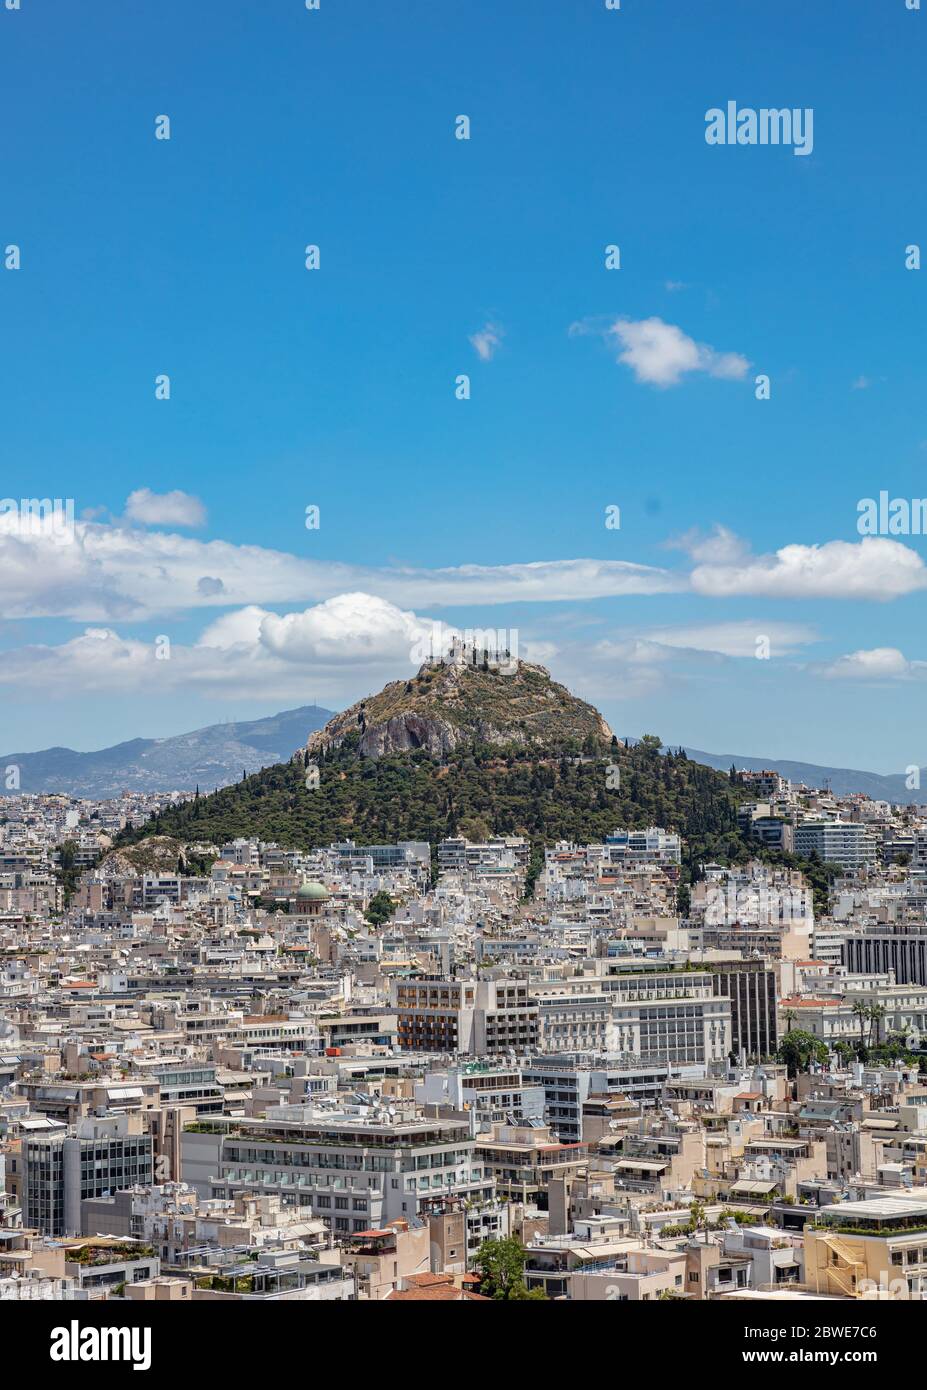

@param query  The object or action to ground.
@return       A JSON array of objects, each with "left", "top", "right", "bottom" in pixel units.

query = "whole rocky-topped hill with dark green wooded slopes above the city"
[{"left": 122, "top": 650, "right": 748, "bottom": 878}]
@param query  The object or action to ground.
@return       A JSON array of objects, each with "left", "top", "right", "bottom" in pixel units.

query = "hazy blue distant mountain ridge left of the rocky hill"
[{"left": 0, "top": 705, "right": 332, "bottom": 801}]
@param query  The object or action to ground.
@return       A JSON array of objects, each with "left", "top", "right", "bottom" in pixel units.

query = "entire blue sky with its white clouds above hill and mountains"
[{"left": 0, "top": 0, "right": 927, "bottom": 771}]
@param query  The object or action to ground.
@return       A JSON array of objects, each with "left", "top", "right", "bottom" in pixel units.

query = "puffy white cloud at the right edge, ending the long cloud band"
[{"left": 689, "top": 532, "right": 927, "bottom": 600}]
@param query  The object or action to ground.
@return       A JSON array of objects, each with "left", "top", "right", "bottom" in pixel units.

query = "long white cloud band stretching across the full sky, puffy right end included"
[{"left": 0, "top": 513, "right": 927, "bottom": 632}]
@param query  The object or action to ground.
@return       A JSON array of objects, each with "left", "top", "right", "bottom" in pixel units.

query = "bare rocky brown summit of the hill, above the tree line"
[{"left": 297, "top": 652, "right": 612, "bottom": 760}]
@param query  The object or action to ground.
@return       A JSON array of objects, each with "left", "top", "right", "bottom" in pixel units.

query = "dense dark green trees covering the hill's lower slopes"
[{"left": 113, "top": 733, "right": 834, "bottom": 910}]
